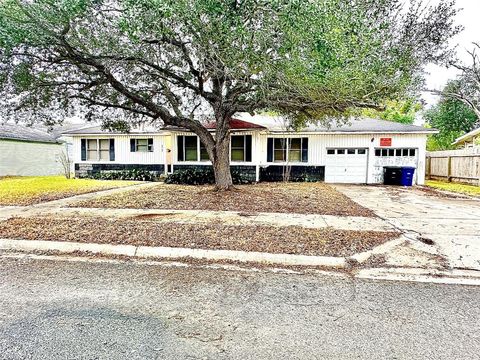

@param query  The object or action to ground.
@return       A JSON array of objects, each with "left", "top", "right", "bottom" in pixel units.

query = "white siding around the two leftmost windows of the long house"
[{"left": 73, "top": 134, "right": 167, "bottom": 165}]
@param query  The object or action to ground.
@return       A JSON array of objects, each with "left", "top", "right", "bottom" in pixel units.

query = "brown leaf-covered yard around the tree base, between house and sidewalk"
[{"left": 71, "top": 183, "right": 375, "bottom": 217}]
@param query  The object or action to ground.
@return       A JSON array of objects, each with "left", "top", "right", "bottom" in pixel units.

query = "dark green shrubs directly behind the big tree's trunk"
[{"left": 165, "top": 168, "right": 252, "bottom": 185}]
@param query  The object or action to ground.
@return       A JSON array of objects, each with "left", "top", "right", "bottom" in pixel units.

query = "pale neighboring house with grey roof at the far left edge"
[{"left": 0, "top": 124, "right": 65, "bottom": 176}]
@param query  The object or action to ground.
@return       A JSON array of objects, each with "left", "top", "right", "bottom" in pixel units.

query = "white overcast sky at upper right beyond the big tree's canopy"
[{"left": 423, "top": 0, "right": 480, "bottom": 105}]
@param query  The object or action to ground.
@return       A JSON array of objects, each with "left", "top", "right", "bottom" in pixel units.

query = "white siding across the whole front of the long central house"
[{"left": 73, "top": 130, "right": 426, "bottom": 184}]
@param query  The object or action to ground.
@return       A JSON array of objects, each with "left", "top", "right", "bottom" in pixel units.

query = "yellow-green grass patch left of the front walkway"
[{"left": 0, "top": 176, "right": 137, "bottom": 205}]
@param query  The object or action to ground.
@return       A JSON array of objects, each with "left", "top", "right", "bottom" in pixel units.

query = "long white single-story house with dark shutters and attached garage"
[{"left": 65, "top": 114, "right": 436, "bottom": 184}]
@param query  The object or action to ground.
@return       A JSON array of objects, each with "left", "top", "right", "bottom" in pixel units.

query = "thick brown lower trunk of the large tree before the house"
[{"left": 212, "top": 134, "right": 233, "bottom": 190}]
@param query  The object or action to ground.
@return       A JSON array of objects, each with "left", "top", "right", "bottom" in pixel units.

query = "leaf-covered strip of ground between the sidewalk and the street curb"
[{"left": 0, "top": 216, "right": 399, "bottom": 256}]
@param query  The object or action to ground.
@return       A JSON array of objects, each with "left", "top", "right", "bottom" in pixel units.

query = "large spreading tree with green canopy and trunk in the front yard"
[{"left": 0, "top": 0, "right": 458, "bottom": 189}]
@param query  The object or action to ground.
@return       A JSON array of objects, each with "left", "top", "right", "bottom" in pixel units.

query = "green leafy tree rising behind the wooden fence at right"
[{"left": 424, "top": 80, "right": 479, "bottom": 151}]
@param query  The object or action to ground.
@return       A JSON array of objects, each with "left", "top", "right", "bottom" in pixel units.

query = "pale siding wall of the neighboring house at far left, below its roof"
[{"left": 0, "top": 139, "right": 65, "bottom": 176}]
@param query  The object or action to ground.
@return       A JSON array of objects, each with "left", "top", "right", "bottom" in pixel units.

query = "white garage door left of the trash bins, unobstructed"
[{"left": 325, "top": 148, "right": 368, "bottom": 184}]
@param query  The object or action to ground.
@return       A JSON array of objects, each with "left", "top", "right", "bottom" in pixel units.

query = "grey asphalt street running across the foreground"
[{"left": 0, "top": 257, "right": 480, "bottom": 360}]
